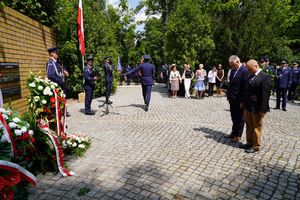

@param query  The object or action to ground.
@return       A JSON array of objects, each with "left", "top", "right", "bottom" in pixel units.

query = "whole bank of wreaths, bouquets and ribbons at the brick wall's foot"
[{"left": 0, "top": 74, "right": 91, "bottom": 200}]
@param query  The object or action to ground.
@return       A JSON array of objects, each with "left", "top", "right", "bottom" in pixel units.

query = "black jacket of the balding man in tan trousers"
[{"left": 244, "top": 70, "right": 272, "bottom": 113}]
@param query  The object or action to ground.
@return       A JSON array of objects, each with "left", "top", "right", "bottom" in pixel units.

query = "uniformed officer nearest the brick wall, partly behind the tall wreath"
[{"left": 46, "top": 47, "right": 64, "bottom": 88}]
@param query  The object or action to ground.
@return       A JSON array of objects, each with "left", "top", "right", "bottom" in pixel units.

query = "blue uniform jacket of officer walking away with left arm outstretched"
[{"left": 127, "top": 62, "right": 155, "bottom": 85}]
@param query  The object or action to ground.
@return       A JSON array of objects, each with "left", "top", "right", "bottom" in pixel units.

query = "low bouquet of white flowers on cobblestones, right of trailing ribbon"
[{"left": 61, "top": 135, "right": 91, "bottom": 156}]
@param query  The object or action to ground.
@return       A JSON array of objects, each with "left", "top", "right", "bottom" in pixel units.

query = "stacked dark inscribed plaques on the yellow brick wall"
[{"left": 0, "top": 62, "right": 21, "bottom": 103}]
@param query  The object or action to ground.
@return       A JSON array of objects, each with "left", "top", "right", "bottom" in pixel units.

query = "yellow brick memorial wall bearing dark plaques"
[{"left": 0, "top": 7, "right": 56, "bottom": 113}]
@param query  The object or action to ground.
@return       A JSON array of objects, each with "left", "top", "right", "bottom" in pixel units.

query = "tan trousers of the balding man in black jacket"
[{"left": 244, "top": 110, "right": 265, "bottom": 150}]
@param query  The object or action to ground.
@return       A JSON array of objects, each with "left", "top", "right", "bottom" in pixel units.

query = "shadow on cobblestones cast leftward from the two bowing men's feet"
[{"left": 194, "top": 127, "right": 239, "bottom": 148}]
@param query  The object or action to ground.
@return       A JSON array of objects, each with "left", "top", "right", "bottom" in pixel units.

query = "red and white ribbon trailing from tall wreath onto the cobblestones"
[{"left": 38, "top": 119, "right": 74, "bottom": 176}]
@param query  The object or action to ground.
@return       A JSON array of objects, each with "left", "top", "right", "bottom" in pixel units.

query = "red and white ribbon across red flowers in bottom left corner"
[{"left": 0, "top": 160, "right": 37, "bottom": 186}]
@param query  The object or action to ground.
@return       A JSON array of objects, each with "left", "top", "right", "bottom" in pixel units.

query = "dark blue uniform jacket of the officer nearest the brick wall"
[{"left": 46, "top": 59, "right": 63, "bottom": 87}]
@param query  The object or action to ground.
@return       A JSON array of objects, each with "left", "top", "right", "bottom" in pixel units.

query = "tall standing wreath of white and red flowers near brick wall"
[{"left": 27, "top": 74, "right": 65, "bottom": 122}]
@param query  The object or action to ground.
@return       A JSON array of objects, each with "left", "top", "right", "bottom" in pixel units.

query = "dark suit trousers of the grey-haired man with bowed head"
[{"left": 229, "top": 100, "right": 244, "bottom": 137}]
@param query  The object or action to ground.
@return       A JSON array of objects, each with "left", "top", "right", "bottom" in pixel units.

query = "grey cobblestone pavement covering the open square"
[{"left": 29, "top": 85, "right": 300, "bottom": 200}]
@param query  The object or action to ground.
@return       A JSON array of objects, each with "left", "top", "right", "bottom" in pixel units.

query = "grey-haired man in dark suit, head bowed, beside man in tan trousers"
[{"left": 225, "top": 55, "right": 249, "bottom": 142}]
